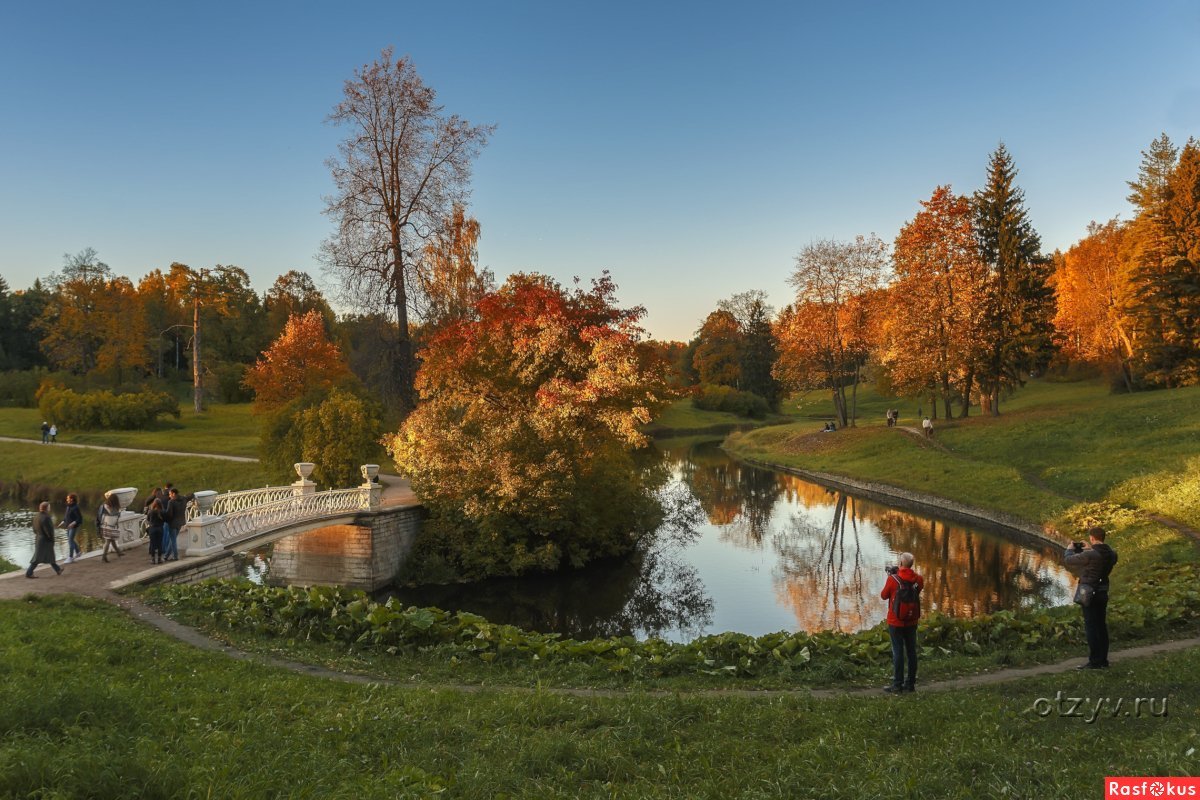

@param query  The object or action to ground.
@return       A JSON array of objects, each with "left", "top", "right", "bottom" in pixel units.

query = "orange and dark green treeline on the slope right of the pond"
[{"left": 659, "top": 134, "right": 1200, "bottom": 425}]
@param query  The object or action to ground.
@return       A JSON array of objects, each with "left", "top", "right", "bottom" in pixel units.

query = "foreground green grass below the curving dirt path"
[{"left": 0, "top": 597, "right": 1200, "bottom": 800}]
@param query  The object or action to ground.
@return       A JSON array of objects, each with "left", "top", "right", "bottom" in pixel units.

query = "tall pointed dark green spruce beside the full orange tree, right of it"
[{"left": 973, "top": 144, "right": 1054, "bottom": 415}]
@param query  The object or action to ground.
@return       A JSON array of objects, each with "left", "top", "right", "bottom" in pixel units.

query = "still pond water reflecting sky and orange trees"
[{"left": 0, "top": 441, "right": 1070, "bottom": 640}]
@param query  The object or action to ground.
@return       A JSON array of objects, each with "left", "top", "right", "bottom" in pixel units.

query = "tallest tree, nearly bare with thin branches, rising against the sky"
[{"left": 322, "top": 47, "right": 494, "bottom": 410}]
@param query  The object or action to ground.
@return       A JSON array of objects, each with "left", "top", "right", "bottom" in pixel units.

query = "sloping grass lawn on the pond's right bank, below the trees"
[{"left": 726, "top": 381, "right": 1200, "bottom": 528}]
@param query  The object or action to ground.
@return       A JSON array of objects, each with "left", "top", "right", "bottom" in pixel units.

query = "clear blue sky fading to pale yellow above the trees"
[{"left": 0, "top": 0, "right": 1200, "bottom": 339}]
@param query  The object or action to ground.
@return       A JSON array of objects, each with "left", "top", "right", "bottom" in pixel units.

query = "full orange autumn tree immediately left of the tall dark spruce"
[{"left": 880, "top": 186, "right": 988, "bottom": 419}]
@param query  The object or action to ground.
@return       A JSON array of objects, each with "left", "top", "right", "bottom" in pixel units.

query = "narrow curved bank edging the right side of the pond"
[{"left": 721, "top": 455, "right": 1069, "bottom": 547}]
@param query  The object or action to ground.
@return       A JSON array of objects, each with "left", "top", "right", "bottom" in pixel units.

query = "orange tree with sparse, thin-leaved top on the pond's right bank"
[{"left": 774, "top": 234, "right": 888, "bottom": 426}]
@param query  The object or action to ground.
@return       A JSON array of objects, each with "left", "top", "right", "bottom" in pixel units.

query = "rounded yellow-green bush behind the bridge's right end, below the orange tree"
[{"left": 259, "top": 389, "right": 384, "bottom": 488}]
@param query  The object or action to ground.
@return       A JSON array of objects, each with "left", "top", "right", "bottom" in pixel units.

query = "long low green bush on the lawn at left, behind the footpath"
[{"left": 37, "top": 384, "right": 179, "bottom": 431}]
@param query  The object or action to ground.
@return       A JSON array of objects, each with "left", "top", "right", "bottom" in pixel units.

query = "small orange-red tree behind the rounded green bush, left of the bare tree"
[{"left": 246, "top": 309, "right": 350, "bottom": 409}]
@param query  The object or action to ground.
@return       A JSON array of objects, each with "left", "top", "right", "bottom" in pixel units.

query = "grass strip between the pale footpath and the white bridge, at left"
[{"left": 0, "top": 441, "right": 268, "bottom": 499}]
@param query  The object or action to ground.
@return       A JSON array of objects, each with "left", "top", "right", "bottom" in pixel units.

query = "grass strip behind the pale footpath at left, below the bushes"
[{"left": 0, "top": 403, "right": 258, "bottom": 458}]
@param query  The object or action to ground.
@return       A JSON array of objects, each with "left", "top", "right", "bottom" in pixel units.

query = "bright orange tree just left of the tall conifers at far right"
[{"left": 1054, "top": 218, "right": 1136, "bottom": 391}]
